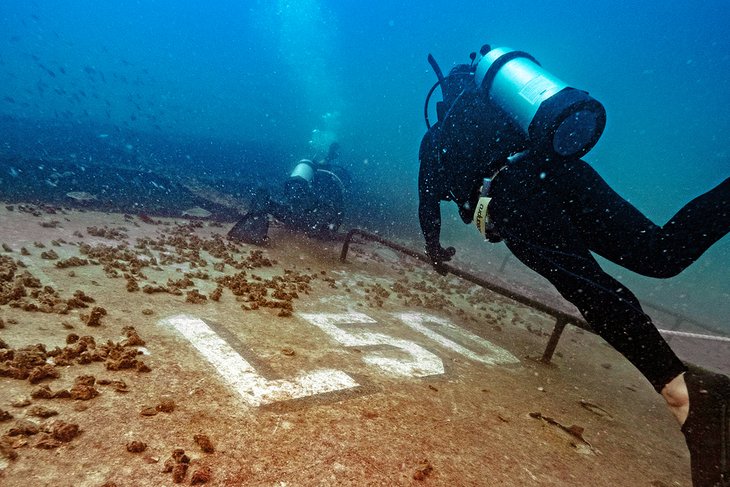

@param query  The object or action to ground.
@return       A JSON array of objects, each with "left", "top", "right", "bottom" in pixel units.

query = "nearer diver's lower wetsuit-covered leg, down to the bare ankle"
[{"left": 490, "top": 195, "right": 685, "bottom": 391}]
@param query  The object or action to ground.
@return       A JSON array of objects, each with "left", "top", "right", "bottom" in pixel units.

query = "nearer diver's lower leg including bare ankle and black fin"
[{"left": 490, "top": 172, "right": 730, "bottom": 487}]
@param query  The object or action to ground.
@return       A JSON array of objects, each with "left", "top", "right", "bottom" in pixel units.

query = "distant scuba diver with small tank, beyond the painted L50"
[{"left": 228, "top": 142, "right": 351, "bottom": 245}]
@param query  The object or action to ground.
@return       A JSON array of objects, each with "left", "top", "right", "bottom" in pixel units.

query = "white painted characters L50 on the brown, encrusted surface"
[{"left": 160, "top": 312, "right": 519, "bottom": 407}]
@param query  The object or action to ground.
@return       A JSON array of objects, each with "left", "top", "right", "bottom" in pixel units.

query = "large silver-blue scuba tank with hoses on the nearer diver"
[{"left": 424, "top": 45, "right": 606, "bottom": 158}]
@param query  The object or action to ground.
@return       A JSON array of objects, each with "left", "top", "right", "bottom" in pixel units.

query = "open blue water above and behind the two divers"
[{"left": 0, "top": 0, "right": 730, "bottom": 326}]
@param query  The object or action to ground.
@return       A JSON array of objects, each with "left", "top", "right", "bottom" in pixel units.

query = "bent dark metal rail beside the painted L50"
[{"left": 340, "top": 228, "right": 730, "bottom": 364}]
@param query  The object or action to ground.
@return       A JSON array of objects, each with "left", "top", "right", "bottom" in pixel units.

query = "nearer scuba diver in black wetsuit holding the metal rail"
[{"left": 418, "top": 46, "right": 730, "bottom": 487}]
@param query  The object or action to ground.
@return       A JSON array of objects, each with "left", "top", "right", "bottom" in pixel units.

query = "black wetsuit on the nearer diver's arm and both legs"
[{"left": 419, "top": 127, "right": 730, "bottom": 391}]
